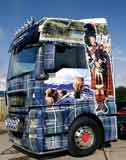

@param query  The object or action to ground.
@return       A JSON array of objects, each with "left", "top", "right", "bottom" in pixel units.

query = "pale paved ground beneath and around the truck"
[{"left": 0, "top": 122, "right": 126, "bottom": 160}]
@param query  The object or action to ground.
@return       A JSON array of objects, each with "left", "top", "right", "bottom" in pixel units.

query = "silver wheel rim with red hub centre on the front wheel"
[{"left": 74, "top": 126, "right": 95, "bottom": 149}]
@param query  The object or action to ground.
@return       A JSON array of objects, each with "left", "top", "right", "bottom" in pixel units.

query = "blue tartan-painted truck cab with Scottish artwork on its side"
[{"left": 5, "top": 17, "right": 117, "bottom": 156}]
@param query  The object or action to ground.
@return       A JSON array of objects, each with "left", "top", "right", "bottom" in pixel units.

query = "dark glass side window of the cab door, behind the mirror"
[{"left": 55, "top": 45, "right": 87, "bottom": 70}]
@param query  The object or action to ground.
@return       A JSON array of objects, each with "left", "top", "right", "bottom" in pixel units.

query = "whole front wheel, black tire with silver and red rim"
[{"left": 68, "top": 117, "right": 103, "bottom": 157}]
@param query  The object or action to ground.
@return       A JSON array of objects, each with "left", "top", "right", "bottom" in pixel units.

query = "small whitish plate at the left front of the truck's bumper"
[{"left": 5, "top": 118, "right": 20, "bottom": 131}]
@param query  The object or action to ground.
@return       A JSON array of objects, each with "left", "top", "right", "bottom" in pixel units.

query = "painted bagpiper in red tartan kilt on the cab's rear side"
[{"left": 85, "top": 24, "right": 113, "bottom": 112}]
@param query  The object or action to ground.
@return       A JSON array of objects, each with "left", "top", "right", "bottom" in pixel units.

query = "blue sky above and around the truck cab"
[{"left": 0, "top": 0, "right": 126, "bottom": 86}]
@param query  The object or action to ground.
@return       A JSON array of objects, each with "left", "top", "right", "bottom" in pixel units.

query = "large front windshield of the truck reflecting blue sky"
[{"left": 9, "top": 47, "right": 38, "bottom": 78}]
